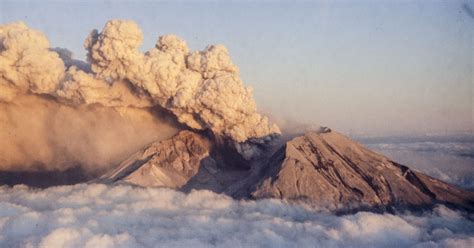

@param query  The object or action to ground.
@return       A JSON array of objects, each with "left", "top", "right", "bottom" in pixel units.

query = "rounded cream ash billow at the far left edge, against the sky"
[{"left": 0, "top": 23, "right": 65, "bottom": 101}]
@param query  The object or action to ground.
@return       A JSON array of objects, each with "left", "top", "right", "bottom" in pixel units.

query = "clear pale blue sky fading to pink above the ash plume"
[{"left": 0, "top": 0, "right": 474, "bottom": 136}]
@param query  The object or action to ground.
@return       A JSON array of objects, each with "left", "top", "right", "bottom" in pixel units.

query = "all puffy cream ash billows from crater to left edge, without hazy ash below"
[{"left": 0, "top": 20, "right": 279, "bottom": 142}]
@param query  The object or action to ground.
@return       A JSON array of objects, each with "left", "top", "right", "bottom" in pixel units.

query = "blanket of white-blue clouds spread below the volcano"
[{"left": 0, "top": 184, "right": 474, "bottom": 247}]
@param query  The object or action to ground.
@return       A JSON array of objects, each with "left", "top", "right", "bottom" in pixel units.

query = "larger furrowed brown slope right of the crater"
[{"left": 251, "top": 129, "right": 474, "bottom": 210}]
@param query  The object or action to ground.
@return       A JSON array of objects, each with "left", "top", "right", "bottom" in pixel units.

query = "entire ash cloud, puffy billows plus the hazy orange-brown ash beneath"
[{"left": 0, "top": 20, "right": 280, "bottom": 169}]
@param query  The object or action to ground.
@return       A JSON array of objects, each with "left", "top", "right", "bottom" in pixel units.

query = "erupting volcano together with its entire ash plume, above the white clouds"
[{"left": 0, "top": 19, "right": 474, "bottom": 211}]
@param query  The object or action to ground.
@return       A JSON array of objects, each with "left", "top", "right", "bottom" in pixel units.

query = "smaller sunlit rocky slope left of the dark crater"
[{"left": 99, "top": 131, "right": 211, "bottom": 188}]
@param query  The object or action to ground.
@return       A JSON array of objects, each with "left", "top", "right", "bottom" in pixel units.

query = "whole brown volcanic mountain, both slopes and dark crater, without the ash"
[{"left": 98, "top": 128, "right": 474, "bottom": 211}]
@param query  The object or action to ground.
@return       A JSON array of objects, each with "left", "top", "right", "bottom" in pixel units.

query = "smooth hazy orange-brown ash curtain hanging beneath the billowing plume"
[{"left": 0, "top": 95, "right": 178, "bottom": 173}]
